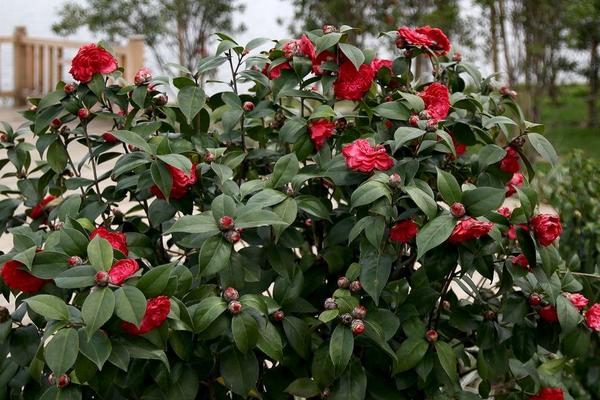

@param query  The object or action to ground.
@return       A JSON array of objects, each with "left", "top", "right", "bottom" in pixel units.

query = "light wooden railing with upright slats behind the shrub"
[{"left": 0, "top": 26, "right": 144, "bottom": 105}]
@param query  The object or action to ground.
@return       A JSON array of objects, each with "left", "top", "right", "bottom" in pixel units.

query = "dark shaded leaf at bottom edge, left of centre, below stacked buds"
[{"left": 220, "top": 347, "right": 258, "bottom": 398}]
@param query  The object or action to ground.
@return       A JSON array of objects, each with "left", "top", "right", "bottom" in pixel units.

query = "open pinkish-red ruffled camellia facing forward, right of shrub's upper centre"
[{"left": 342, "top": 139, "right": 394, "bottom": 172}]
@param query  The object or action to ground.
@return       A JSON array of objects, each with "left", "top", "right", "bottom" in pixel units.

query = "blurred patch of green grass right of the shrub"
[{"left": 541, "top": 85, "right": 600, "bottom": 159}]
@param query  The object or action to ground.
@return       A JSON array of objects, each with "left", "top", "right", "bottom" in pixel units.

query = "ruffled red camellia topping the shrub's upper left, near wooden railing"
[{"left": 69, "top": 43, "right": 118, "bottom": 83}]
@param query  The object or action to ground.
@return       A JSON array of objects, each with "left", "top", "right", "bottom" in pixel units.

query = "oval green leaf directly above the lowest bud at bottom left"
[{"left": 44, "top": 328, "right": 79, "bottom": 376}]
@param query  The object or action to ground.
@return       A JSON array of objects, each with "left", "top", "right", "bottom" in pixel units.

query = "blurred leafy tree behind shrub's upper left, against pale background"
[{"left": 52, "top": 0, "right": 244, "bottom": 69}]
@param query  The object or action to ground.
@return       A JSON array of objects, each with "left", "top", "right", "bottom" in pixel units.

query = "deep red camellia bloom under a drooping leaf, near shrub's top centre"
[{"left": 333, "top": 61, "right": 375, "bottom": 101}]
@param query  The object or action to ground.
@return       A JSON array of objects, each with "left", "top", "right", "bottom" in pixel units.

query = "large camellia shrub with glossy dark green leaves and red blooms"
[{"left": 0, "top": 26, "right": 600, "bottom": 400}]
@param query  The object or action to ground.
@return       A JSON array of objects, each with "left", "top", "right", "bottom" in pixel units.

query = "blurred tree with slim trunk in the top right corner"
[{"left": 566, "top": 0, "right": 600, "bottom": 128}]
